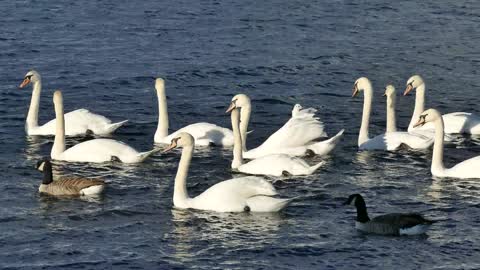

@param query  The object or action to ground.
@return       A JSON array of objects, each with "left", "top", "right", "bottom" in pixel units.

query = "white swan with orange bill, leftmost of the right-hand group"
[{"left": 352, "top": 77, "right": 433, "bottom": 151}]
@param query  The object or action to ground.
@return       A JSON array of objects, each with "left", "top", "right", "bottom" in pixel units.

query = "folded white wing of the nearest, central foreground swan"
[{"left": 190, "top": 176, "right": 277, "bottom": 212}]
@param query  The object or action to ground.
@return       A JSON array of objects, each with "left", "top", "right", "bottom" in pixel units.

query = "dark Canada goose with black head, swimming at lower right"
[{"left": 345, "top": 194, "right": 434, "bottom": 235}]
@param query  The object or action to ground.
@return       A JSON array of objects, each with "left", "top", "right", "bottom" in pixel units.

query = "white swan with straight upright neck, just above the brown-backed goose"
[{"left": 50, "top": 91, "right": 158, "bottom": 163}]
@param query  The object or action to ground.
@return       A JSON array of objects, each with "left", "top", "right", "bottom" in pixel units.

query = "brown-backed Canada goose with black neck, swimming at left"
[{"left": 37, "top": 160, "right": 105, "bottom": 196}]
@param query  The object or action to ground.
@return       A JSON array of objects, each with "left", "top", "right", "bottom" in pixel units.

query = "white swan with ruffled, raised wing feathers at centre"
[{"left": 227, "top": 94, "right": 344, "bottom": 159}]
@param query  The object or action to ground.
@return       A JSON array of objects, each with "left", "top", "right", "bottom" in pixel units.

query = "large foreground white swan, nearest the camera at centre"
[{"left": 164, "top": 132, "right": 291, "bottom": 212}]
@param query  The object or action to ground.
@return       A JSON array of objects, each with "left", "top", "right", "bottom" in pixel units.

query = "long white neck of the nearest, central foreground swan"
[{"left": 173, "top": 146, "right": 194, "bottom": 207}]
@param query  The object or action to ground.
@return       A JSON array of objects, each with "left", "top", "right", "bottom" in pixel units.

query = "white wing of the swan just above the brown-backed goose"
[{"left": 55, "top": 139, "right": 141, "bottom": 163}]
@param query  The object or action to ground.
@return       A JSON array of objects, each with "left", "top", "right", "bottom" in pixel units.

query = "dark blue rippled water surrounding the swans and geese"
[{"left": 0, "top": 0, "right": 480, "bottom": 269}]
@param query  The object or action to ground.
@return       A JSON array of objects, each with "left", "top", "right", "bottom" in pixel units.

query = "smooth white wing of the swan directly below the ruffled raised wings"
[{"left": 238, "top": 154, "right": 321, "bottom": 176}]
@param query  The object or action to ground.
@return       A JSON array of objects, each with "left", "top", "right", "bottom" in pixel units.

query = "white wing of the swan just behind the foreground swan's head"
[{"left": 162, "top": 122, "right": 233, "bottom": 146}]
